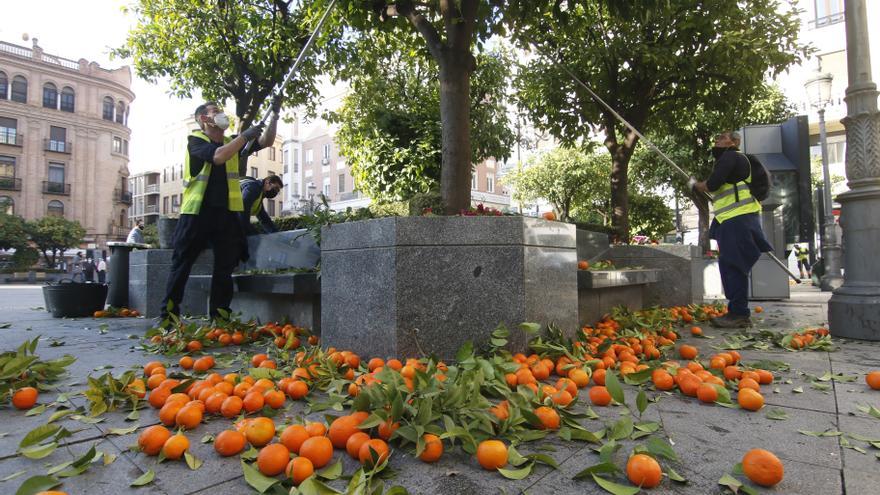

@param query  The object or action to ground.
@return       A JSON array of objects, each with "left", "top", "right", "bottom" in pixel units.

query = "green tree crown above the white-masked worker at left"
[{"left": 113, "top": 0, "right": 326, "bottom": 129}]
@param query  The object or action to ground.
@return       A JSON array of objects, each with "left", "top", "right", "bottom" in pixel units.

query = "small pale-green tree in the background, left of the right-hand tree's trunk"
[{"left": 503, "top": 148, "right": 609, "bottom": 223}]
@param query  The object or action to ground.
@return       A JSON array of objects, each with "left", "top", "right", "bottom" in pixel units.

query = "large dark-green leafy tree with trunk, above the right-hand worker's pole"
[{"left": 511, "top": 0, "right": 808, "bottom": 240}]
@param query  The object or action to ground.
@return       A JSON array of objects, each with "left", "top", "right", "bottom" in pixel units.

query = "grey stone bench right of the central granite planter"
[{"left": 578, "top": 268, "right": 660, "bottom": 327}]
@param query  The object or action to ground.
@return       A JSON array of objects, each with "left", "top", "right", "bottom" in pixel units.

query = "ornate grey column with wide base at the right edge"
[{"left": 828, "top": 0, "right": 880, "bottom": 340}]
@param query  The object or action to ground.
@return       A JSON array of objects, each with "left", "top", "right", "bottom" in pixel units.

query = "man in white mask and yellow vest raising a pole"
[{"left": 162, "top": 98, "right": 280, "bottom": 320}]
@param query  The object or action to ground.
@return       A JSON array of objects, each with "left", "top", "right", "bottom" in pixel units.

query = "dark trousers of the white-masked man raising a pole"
[{"left": 162, "top": 205, "right": 242, "bottom": 317}]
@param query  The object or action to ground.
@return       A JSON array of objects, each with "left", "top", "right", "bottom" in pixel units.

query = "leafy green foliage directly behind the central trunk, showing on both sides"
[{"left": 328, "top": 38, "right": 514, "bottom": 203}]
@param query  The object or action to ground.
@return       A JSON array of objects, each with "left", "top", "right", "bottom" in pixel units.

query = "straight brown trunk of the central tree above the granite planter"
[{"left": 440, "top": 51, "right": 474, "bottom": 215}]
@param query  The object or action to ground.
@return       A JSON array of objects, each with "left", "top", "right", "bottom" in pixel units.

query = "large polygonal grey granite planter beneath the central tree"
[{"left": 321, "top": 217, "right": 578, "bottom": 359}]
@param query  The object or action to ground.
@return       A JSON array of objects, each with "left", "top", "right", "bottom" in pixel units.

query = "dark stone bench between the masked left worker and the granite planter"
[{"left": 186, "top": 273, "right": 321, "bottom": 334}]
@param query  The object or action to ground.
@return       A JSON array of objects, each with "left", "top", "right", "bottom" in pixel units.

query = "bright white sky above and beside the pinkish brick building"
[{"left": 0, "top": 0, "right": 302, "bottom": 174}]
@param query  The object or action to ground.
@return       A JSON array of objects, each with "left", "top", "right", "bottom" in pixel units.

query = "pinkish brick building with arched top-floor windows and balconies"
[{"left": 0, "top": 38, "right": 134, "bottom": 249}]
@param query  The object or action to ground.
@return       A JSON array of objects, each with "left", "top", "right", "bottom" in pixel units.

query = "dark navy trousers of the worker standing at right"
[{"left": 709, "top": 213, "right": 773, "bottom": 316}]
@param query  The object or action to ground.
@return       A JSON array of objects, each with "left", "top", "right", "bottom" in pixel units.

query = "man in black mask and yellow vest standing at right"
[{"left": 693, "top": 131, "right": 773, "bottom": 328}]
